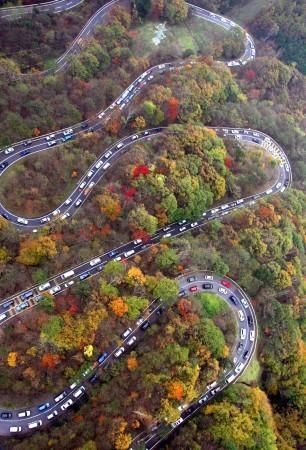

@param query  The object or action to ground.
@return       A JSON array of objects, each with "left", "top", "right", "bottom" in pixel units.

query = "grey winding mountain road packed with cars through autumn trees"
[{"left": 0, "top": 0, "right": 292, "bottom": 449}]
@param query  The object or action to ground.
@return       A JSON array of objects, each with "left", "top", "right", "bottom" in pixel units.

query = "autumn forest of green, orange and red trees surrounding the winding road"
[{"left": 0, "top": 0, "right": 306, "bottom": 450}]
